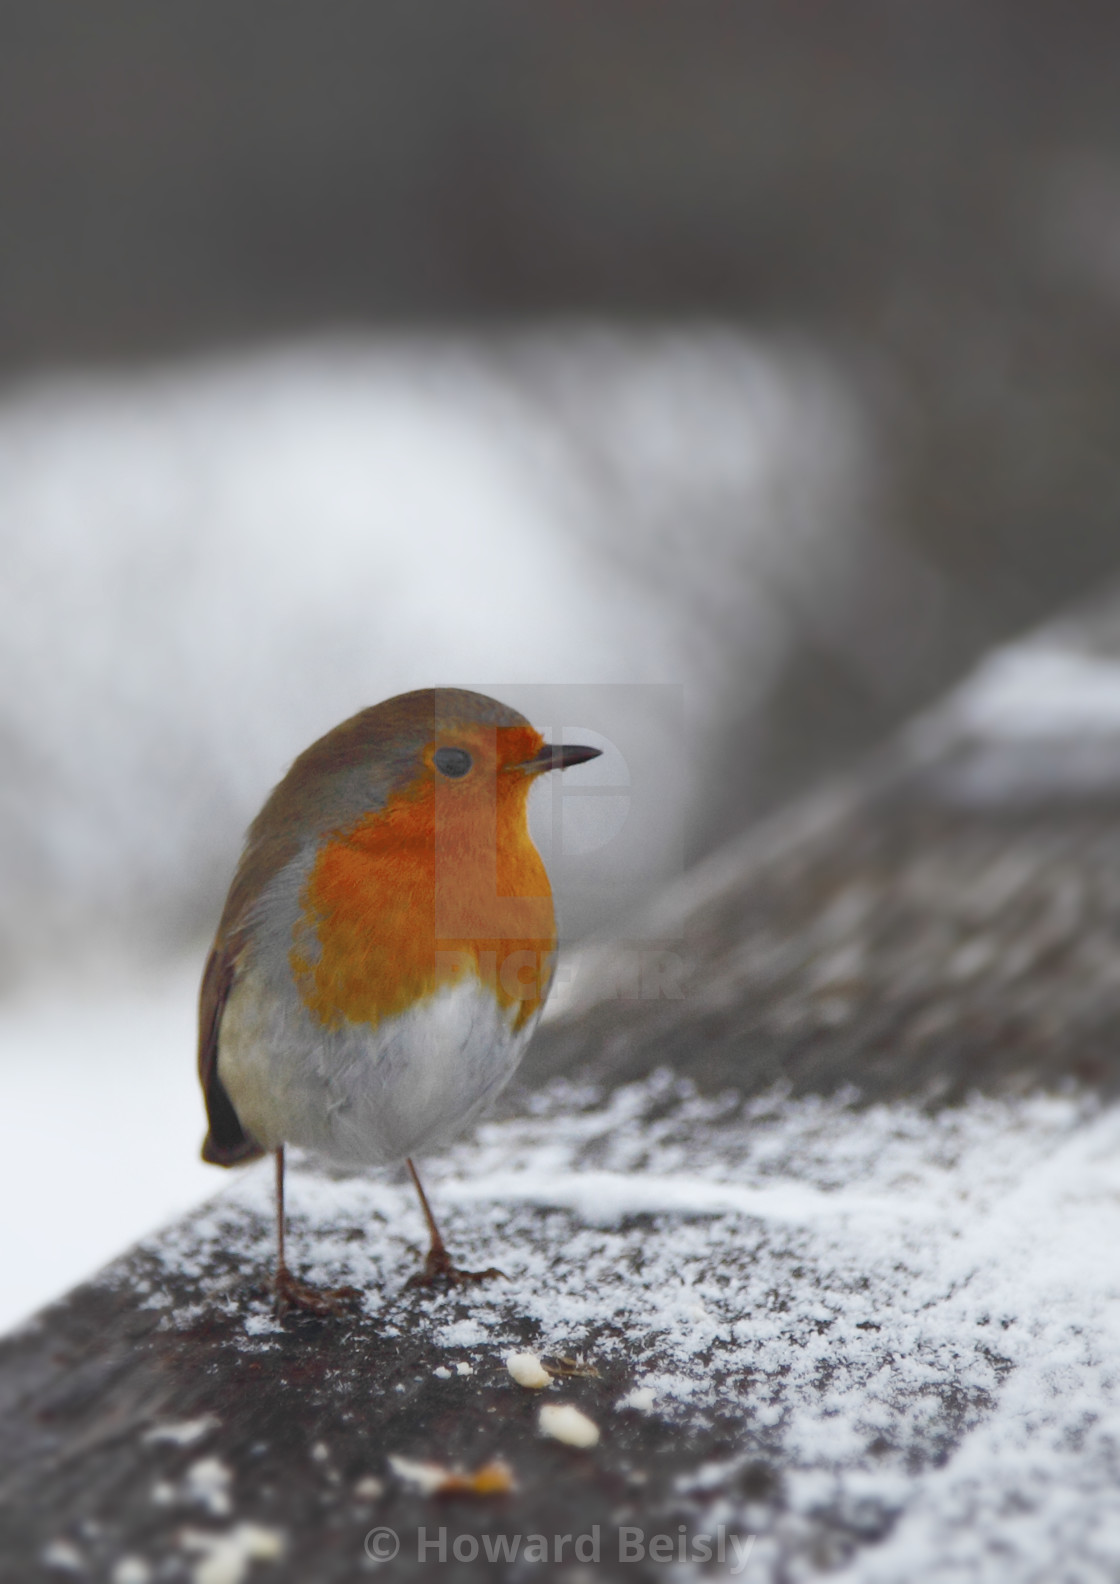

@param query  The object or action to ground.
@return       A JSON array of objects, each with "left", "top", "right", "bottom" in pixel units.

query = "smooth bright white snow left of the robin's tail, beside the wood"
[{"left": 0, "top": 963, "right": 222, "bottom": 1331}]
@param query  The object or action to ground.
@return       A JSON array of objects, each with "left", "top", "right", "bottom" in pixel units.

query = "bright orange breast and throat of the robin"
[{"left": 290, "top": 741, "right": 556, "bottom": 1028}]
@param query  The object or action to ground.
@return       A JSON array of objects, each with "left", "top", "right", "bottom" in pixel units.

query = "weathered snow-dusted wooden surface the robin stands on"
[{"left": 0, "top": 607, "right": 1120, "bottom": 1584}]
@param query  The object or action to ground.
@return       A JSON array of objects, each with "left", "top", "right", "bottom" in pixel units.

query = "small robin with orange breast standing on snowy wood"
[{"left": 198, "top": 687, "right": 599, "bottom": 1315}]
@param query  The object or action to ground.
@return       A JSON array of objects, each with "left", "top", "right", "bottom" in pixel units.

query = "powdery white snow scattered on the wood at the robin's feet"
[{"left": 114, "top": 1074, "right": 1120, "bottom": 1584}]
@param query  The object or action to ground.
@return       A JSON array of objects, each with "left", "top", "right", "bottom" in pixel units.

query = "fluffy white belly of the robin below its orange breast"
[{"left": 219, "top": 971, "right": 535, "bottom": 1166}]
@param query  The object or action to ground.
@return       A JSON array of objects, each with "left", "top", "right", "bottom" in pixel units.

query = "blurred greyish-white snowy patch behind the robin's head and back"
[{"left": 0, "top": 326, "right": 867, "bottom": 976}]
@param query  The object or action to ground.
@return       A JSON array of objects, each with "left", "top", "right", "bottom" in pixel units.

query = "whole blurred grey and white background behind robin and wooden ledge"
[{"left": 0, "top": 0, "right": 1120, "bottom": 1324}]
